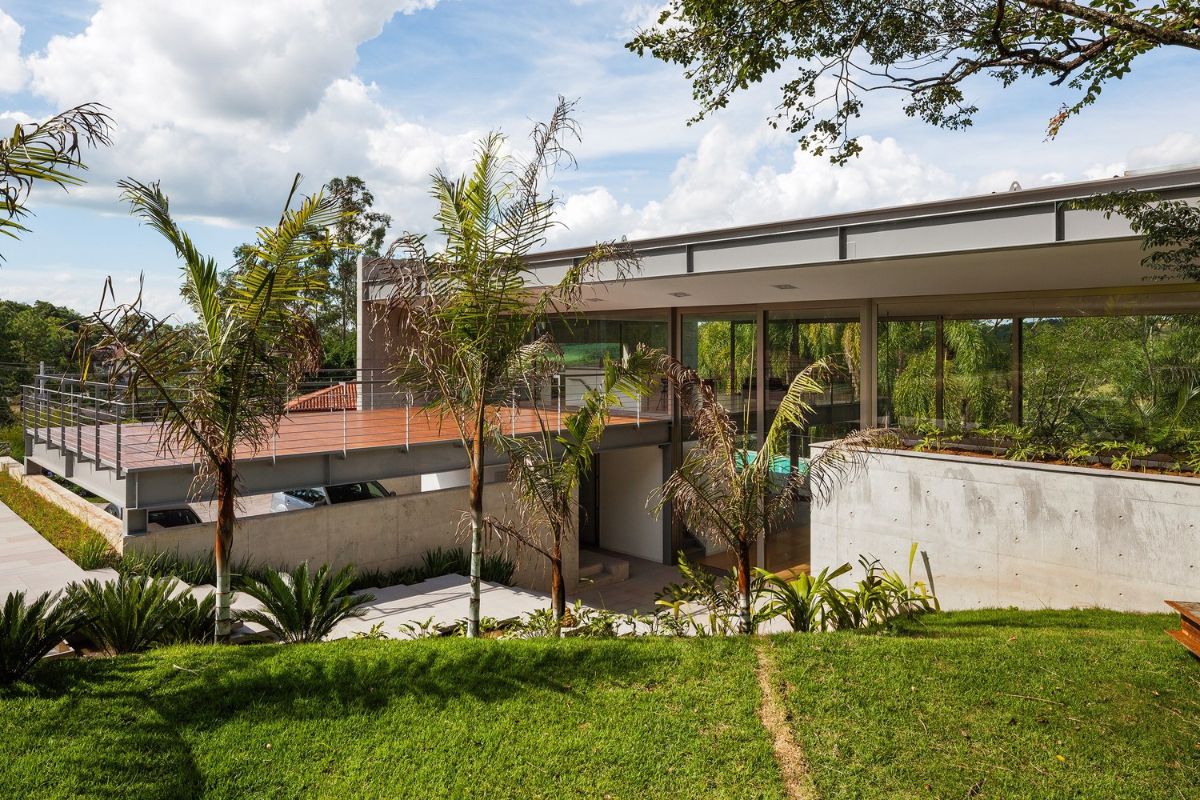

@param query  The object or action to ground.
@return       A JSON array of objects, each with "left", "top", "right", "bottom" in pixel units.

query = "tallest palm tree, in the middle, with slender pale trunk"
[{"left": 377, "top": 97, "right": 637, "bottom": 636}]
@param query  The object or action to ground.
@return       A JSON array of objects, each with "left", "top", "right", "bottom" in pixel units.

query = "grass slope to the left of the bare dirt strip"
[{"left": 0, "top": 639, "right": 782, "bottom": 800}]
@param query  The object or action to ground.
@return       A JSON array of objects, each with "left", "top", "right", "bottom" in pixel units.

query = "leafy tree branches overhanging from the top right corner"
[{"left": 628, "top": 0, "right": 1200, "bottom": 162}]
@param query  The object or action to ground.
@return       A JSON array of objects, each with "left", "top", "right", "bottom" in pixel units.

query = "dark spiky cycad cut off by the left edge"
[{"left": 0, "top": 591, "right": 83, "bottom": 686}]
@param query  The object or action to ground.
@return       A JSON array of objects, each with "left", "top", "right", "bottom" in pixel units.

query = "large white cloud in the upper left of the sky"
[{"left": 17, "top": 0, "right": 451, "bottom": 225}]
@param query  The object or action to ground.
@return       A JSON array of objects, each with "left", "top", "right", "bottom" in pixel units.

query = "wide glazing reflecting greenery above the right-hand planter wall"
[{"left": 878, "top": 314, "right": 1200, "bottom": 453}]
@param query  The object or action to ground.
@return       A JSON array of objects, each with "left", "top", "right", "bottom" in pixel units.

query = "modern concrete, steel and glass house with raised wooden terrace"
[{"left": 26, "top": 168, "right": 1200, "bottom": 609}]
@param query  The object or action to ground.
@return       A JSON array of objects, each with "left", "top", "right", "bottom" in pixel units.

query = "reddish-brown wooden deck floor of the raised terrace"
[{"left": 32, "top": 408, "right": 658, "bottom": 470}]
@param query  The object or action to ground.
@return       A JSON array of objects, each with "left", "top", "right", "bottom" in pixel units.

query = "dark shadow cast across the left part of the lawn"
[{"left": 19, "top": 639, "right": 681, "bottom": 798}]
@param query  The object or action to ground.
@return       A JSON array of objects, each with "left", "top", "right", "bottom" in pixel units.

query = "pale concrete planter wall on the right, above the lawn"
[{"left": 812, "top": 451, "right": 1200, "bottom": 612}]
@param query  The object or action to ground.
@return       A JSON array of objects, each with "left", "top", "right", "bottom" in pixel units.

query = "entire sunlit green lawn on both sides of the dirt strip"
[{"left": 0, "top": 612, "right": 1200, "bottom": 800}]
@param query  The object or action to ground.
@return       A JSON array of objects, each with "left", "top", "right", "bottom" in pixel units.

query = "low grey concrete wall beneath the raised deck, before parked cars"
[{"left": 122, "top": 485, "right": 578, "bottom": 589}]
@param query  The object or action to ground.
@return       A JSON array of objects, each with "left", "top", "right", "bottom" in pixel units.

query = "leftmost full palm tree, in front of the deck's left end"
[{"left": 84, "top": 175, "right": 341, "bottom": 642}]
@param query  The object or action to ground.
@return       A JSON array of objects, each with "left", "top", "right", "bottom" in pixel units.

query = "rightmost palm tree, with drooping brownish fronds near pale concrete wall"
[{"left": 650, "top": 360, "right": 887, "bottom": 633}]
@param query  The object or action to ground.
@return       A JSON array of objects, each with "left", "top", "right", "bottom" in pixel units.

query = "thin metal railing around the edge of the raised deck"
[{"left": 20, "top": 371, "right": 670, "bottom": 479}]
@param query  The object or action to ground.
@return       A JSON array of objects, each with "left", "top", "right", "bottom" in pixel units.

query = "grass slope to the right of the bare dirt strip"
[{"left": 773, "top": 610, "right": 1200, "bottom": 800}]
